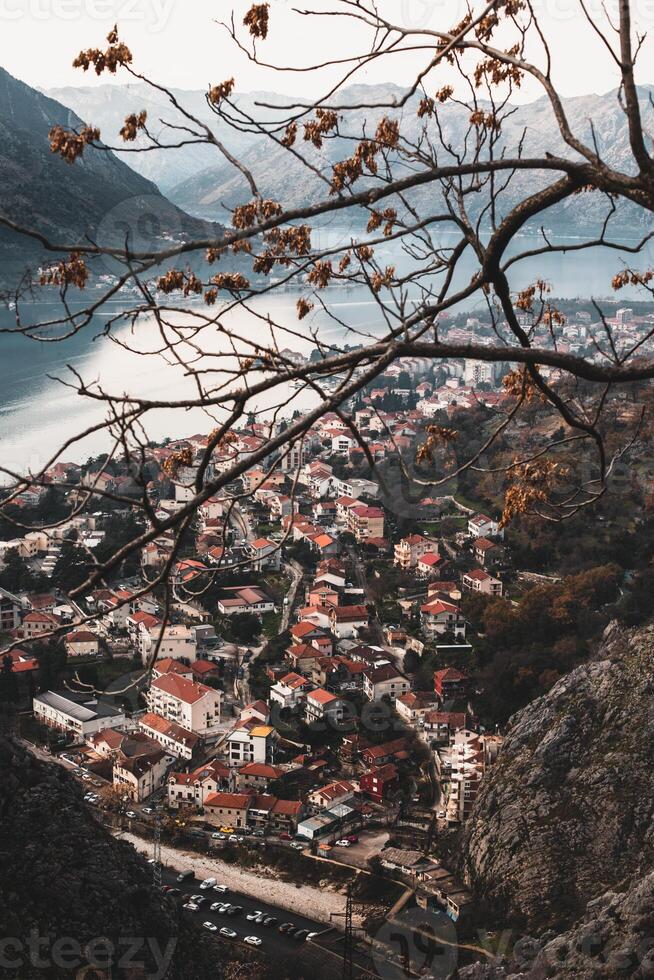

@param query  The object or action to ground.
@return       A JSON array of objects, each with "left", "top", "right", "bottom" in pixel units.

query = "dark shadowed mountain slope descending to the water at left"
[{"left": 0, "top": 68, "right": 218, "bottom": 281}]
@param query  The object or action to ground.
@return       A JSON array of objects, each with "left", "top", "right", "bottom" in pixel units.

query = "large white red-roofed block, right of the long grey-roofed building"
[{"left": 145, "top": 673, "right": 222, "bottom": 741}]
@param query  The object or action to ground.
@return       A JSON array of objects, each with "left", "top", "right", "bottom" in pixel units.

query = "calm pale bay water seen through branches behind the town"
[{"left": 0, "top": 230, "right": 654, "bottom": 470}]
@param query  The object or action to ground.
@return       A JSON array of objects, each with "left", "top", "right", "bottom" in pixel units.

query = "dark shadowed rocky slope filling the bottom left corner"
[{"left": 0, "top": 738, "right": 221, "bottom": 980}]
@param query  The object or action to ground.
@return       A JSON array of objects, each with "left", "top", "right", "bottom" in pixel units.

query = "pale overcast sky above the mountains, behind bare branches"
[{"left": 0, "top": 0, "right": 654, "bottom": 101}]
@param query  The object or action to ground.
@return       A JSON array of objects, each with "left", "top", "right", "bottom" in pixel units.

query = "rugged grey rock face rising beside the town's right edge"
[{"left": 460, "top": 624, "right": 654, "bottom": 932}]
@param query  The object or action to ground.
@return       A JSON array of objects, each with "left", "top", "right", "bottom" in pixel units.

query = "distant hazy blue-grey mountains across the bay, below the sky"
[{"left": 49, "top": 84, "right": 654, "bottom": 235}]
